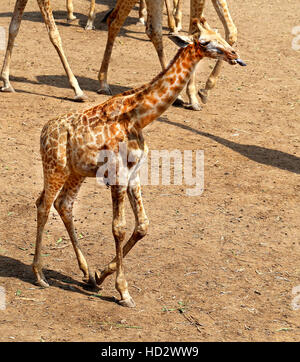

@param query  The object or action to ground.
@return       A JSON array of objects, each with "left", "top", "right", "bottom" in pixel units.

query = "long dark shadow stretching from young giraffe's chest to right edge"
[{"left": 158, "top": 117, "right": 300, "bottom": 174}]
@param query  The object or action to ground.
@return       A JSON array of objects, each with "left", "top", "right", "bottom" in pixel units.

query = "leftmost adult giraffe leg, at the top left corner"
[{"left": 0, "top": 0, "right": 28, "bottom": 92}]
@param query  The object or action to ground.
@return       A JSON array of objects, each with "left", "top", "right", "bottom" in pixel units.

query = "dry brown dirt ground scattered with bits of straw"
[{"left": 0, "top": 0, "right": 300, "bottom": 341}]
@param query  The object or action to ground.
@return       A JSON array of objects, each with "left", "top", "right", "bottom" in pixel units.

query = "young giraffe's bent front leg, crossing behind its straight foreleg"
[{"left": 95, "top": 178, "right": 149, "bottom": 292}]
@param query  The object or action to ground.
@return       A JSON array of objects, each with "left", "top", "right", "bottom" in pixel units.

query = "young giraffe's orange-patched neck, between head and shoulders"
[{"left": 134, "top": 44, "right": 203, "bottom": 129}]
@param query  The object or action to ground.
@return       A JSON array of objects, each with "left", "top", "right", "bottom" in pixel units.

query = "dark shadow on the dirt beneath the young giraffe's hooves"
[{"left": 0, "top": 255, "right": 117, "bottom": 303}]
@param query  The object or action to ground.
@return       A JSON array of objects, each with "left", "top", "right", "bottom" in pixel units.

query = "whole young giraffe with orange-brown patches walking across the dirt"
[{"left": 33, "top": 18, "right": 245, "bottom": 307}]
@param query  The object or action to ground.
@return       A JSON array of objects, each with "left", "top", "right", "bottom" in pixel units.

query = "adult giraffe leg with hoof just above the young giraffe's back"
[{"left": 97, "top": 0, "right": 137, "bottom": 95}]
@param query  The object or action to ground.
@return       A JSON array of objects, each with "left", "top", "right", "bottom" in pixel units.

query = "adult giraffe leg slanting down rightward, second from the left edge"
[{"left": 37, "top": 0, "right": 87, "bottom": 101}]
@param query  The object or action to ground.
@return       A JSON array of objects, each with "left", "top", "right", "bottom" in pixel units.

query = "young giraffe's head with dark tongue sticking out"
[{"left": 169, "top": 17, "right": 246, "bottom": 66}]
